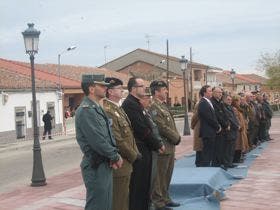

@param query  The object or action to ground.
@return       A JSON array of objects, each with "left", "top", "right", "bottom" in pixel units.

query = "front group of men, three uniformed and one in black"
[{"left": 75, "top": 75, "right": 181, "bottom": 210}]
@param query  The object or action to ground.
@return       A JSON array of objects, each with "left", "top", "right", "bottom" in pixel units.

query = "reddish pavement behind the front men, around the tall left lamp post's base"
[{"left": 0, "top": 136, "right": 192, "bottom": 210}]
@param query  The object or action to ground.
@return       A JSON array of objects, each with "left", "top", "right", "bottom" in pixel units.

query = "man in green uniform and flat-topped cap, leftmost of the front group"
[{"left": 75, "top": 75, "right": 123, "bottom": 210}]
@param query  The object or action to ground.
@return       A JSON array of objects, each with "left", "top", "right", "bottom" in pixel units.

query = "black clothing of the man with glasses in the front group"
[{"left": 122, "top": 94, "right": 163, "bottom": 210}]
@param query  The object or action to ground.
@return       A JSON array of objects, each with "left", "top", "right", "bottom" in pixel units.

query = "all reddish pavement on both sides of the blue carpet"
[{"left": 0, "top": 118, "right": 280, "bottom": 210}]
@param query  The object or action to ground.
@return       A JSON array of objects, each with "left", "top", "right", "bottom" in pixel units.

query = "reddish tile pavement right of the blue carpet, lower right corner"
[{"left": 221, "top": 135, "right": 280, "bottom": 210}]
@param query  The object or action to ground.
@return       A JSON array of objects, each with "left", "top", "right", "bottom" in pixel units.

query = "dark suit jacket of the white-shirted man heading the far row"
[{"left": 198, "top": 98, "right": 220, "bottom": 138}]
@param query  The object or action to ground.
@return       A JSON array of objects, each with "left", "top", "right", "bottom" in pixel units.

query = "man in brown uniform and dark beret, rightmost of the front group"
[{"left": 150, "top": 81, "right": 181, "bottom": 210}]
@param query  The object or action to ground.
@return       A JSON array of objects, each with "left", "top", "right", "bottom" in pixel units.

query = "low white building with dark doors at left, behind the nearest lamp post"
[{"left": 0, "top": 89, "right": 63, "bottom": 143}]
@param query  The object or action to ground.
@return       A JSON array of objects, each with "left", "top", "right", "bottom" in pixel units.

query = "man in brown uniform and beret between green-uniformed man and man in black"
[{"left": 103, "top": 77, "right": 141, "bottom": 210}]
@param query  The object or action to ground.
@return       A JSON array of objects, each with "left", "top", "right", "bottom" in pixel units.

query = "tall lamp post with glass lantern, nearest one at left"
[{"left": 22, "top": 23, "right": 47, "bottom": 187}]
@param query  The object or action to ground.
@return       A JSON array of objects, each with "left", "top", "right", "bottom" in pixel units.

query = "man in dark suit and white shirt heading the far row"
[{"left": 198, "top": 85, "right": 221, "bottom": 167}]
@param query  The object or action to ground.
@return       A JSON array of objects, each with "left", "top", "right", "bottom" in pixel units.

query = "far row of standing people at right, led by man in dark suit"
[{"left": 191, "top": 85, "right": 273, "bottom": 170}]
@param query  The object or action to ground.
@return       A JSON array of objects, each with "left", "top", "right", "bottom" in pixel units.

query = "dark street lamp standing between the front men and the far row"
[{"left": 179, "top": 56, "right": 191, "bottom": 136}]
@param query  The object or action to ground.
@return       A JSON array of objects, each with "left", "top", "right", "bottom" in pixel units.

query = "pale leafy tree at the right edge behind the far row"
[{"left": 258, "top": 50, "right": 280, "bottom": 88}]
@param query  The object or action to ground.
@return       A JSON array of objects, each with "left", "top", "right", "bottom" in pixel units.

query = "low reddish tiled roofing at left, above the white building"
[{"left": 0, "top": 58, "right": 133, "bottom": 88}]
